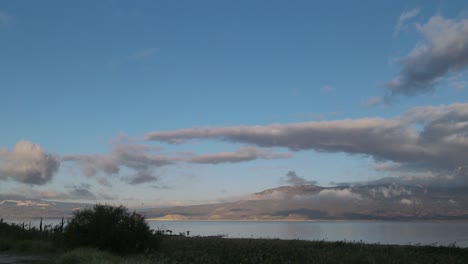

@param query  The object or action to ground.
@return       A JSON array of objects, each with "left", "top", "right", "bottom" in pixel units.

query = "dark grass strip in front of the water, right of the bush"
[{"left": 48, "top": 236, "right": 468, "bottom": 264}]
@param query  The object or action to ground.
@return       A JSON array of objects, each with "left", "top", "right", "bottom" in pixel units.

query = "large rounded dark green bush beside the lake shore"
[{"left": 64, "top": 205, "right": 155, "bottom": 254}]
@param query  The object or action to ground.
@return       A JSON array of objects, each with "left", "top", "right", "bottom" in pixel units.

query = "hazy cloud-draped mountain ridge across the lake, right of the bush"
[{"left": 142, "top": 184, "right": 468, "bottom": 220}]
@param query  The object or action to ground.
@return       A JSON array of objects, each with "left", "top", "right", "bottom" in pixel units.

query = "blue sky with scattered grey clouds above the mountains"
[{"left": 0, "top": 0, "right": 468, "bottom": 206}]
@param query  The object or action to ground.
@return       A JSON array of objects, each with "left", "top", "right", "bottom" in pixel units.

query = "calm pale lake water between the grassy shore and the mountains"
[{"left": 149, "top": 221, "right": 468, "bottom": 247}]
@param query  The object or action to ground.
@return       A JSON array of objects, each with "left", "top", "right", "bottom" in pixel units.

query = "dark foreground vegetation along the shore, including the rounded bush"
[{"left": 0, "top": 206, "right": 468, "bottom": 264}]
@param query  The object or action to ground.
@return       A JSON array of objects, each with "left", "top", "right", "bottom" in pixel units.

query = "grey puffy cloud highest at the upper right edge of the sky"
[{"left": 387, "top": 16, "right": 468, "bottom": 97}]
